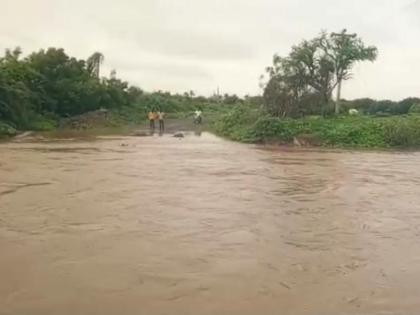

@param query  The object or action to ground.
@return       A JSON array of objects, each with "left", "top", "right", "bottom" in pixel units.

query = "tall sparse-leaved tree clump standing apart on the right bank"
[{"left": 262, "top": 30, "right": 378, "bottom": 117}]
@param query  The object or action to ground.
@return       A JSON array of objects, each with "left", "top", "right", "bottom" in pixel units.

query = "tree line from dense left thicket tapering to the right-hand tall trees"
[{"left": 0, "top": 48, "right": 249, "bottom": 129}]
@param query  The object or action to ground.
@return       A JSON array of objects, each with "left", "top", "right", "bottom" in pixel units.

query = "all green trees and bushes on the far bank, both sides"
[{"left": 0, "top": 30, "right": 420, "bottom": 148}]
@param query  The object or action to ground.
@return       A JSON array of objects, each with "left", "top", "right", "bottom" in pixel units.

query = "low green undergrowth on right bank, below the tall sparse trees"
[{"left": 215, "top": 107, "right": 420, "bottom": 148}]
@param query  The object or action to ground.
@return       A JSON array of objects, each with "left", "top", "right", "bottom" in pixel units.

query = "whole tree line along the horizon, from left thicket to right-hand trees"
[{"left": 0, "top": 30, "right": 420, "bottom": 135}]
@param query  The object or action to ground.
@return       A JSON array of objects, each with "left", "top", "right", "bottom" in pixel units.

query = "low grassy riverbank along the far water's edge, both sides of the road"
[{"left": 5, "top": 105, "right": 420, "bottom": 149}]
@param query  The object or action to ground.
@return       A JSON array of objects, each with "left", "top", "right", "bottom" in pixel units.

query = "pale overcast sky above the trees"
[{"left": 0, "top": 0, "right": 420, "bottom": 99}]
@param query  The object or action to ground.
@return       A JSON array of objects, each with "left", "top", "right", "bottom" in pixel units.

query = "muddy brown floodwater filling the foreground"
[{"left": 0, "top": 134, "right": 420, "bottom": 315}]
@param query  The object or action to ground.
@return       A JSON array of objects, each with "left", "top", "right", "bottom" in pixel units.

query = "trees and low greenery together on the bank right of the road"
[{"left": 215, "top": 30, "right": 420, "bottom": 148}]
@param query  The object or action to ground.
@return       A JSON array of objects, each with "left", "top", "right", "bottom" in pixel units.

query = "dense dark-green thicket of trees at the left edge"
[{"left": 0, "top": 48, "right": 142, "bottom": 128}]
